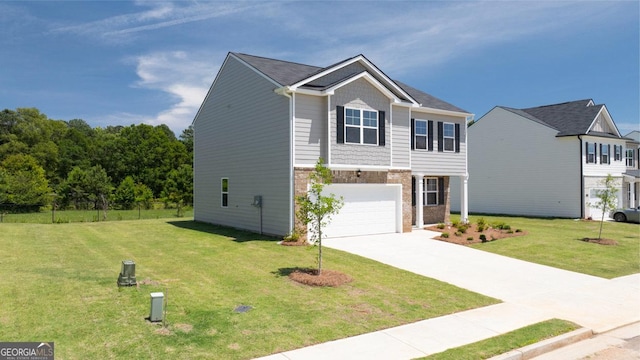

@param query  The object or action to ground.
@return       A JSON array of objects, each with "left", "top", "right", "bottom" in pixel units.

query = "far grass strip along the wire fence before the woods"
[{"left": 2, "top": 207, "right": 193, "bottom": 224}]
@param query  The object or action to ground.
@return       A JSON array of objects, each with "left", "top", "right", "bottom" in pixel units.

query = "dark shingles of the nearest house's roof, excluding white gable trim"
[{"left": 232, "top": 53, "right": 467, "bottom": 113}]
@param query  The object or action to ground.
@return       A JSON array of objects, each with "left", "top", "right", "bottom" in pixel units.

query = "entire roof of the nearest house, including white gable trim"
[{"left": 231, "top": 53, "right": 468, "bottom": 113}]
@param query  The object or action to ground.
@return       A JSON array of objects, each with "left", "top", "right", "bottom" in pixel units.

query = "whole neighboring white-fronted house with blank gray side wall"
[{"left": 452, "top": 99, "right": 637, "bottom": 219}]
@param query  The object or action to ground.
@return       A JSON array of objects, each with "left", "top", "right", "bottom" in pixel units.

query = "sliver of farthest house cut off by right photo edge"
[{"left": 622, "top": 130, "right": 640, "bottom": 208}]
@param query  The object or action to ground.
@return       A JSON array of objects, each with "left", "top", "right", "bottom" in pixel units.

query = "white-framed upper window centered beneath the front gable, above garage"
[{"left": 344, "top": 108, "right": 378, "bottom": 145}]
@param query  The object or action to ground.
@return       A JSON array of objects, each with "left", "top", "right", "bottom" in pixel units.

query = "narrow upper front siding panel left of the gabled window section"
[{"left": 295, "top": 94, "right": 327, "bottom": 165}]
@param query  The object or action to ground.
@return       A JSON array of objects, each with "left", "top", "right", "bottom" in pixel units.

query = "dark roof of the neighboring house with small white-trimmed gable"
[{"left": 499, "top": 99, "right": 620, "bottom": 138}]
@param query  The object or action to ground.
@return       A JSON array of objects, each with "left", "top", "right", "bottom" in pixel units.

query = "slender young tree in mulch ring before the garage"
[{"left": 296, "top": 158, "right": 344, "bottom": 275}]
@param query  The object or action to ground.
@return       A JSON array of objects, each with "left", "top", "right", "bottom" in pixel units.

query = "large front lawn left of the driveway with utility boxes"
[{"left": 0, "top": 219, "right": 498, "bottom": 359}]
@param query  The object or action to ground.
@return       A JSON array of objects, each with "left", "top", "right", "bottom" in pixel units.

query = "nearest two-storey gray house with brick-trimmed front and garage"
[{"left": 193, "top": 53, "right": 471, "bottom": 237}]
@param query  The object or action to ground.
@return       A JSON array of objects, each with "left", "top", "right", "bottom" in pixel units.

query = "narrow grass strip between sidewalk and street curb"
[{"left": 422, "top": 319, "right": 579, "bottom": 360}]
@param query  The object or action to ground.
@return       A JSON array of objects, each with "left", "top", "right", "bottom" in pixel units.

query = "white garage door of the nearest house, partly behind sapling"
[{"left": 323, "top": 184, "right": 402, "bottom": 237}]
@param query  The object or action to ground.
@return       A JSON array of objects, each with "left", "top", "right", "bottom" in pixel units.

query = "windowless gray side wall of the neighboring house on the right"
[{"left": 451, "top": 108, "right": 582, "bottom": 218}]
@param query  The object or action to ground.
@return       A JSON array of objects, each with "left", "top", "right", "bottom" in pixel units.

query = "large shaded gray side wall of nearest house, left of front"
[{"left": 194, "top": 56, "right": 291, "bottom": 235}]
